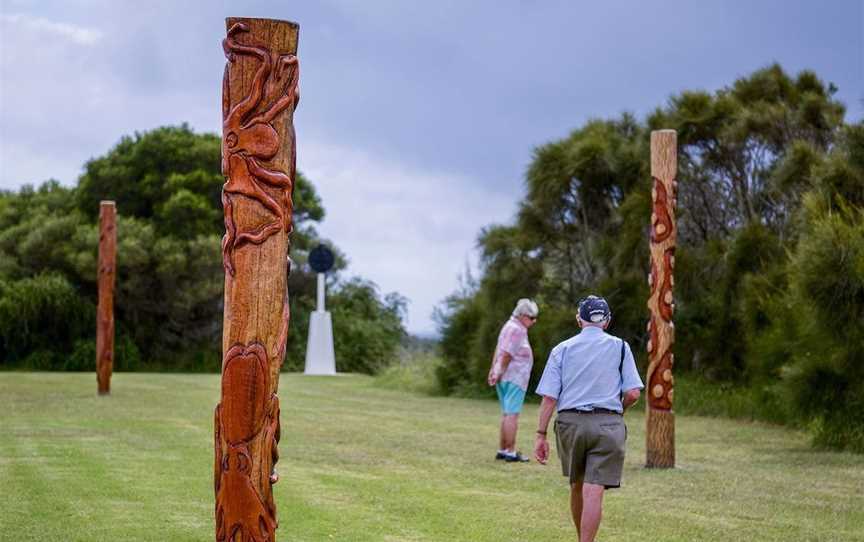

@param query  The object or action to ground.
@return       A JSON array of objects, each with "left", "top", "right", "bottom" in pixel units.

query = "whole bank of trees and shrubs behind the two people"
[{"left": 437, "top": 65, "right": 864, "bottom": 451}]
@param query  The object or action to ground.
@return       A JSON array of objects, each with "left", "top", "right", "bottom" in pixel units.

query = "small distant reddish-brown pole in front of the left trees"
[{"left": 96, "top": 201, "right": 117, "bottom": 395}]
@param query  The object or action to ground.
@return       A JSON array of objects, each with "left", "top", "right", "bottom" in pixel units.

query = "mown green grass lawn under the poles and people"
[{"left": 0, "top": 373, "right": 864, "bottom": 542}]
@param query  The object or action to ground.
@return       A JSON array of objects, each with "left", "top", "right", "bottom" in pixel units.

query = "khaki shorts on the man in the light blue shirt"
[{"left": 555, "top": 412, "right": 627, "bottom": 489}]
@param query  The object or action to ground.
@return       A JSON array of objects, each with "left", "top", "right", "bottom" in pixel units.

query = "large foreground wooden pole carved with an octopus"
[{"left": 214, "top": 18, "right": 299, "bottom": 542}]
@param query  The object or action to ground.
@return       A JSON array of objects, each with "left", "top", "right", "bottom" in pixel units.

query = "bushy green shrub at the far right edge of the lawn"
[{"left": 786, "top": 209, "right": 864, "bottom": 452}]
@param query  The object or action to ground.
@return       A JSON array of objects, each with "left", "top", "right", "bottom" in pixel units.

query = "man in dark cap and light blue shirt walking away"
[{"left": 534, "top": 295, "right": 644, "bottom": 542}]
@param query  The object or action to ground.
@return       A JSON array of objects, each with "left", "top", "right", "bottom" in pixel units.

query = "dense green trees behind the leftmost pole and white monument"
[{"left": 0, "top": 125, "right": 406, "bottom": 373}]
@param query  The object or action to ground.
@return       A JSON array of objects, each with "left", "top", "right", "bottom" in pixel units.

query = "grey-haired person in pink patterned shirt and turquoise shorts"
[{"left": 487, "top": 299, "right": 540, "bottom": 463}]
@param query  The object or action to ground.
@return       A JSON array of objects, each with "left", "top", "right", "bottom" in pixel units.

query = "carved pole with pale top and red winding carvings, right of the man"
[{"left": 645, "top": 130, "right": 678, "bottom": 468}]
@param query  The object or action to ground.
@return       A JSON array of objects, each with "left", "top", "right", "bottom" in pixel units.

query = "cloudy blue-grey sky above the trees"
[{"left": 0, "top": 0, "right": 864, "bottom": 333}]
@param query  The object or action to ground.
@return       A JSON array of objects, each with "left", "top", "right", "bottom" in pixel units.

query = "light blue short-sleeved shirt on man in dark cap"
[{"left": 537, "top": 327, "right": 645, "bottom": 412}]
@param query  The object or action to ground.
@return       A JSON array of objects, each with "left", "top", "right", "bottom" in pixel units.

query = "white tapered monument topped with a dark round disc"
[{"left": 304, "top": 245, "right": 336, "bottom": 375}]
